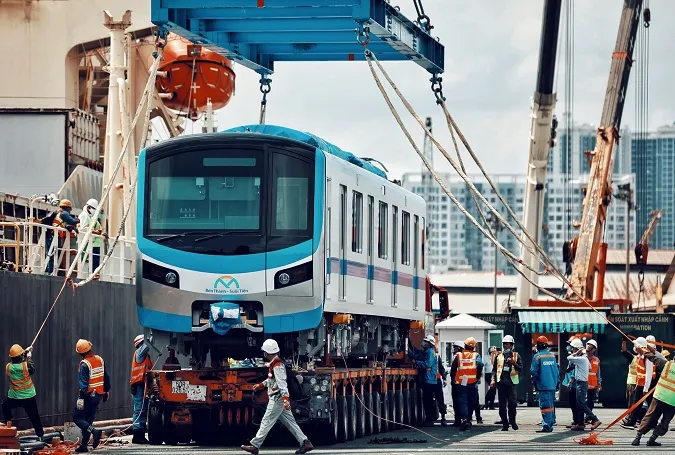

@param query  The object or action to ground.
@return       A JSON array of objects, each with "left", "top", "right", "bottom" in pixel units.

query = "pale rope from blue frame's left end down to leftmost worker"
[{"left": 29, "top": 47, "right": 163, "bottom": 348}]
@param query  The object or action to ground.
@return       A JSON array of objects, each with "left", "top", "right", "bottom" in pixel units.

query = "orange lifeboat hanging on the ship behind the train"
[{"left": 155, "top": 35, "right": 235, "bottom": 120}]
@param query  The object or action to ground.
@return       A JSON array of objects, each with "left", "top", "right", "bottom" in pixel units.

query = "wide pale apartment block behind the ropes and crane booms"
[{"left": 402, "top": 172, "right": 635, "bottom": 274}]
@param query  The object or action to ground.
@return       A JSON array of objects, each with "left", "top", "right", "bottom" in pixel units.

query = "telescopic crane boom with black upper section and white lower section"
[{"left": 516, "top": 0, "right": 562, "bottom": 307}]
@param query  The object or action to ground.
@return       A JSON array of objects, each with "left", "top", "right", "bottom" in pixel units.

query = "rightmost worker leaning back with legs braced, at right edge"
[{"left": 632, "top": 343, "right": 675, "bottom": 447}]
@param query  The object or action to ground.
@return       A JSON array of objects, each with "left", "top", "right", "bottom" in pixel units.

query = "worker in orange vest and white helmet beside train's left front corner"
[{"left": 129, "top": 335, "right": 152, "bottom": 444}]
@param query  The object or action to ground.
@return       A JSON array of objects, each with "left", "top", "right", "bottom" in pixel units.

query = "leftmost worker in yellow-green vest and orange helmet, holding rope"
[{"left": 2, "top": 344, "right": 45, "bottom": 438}]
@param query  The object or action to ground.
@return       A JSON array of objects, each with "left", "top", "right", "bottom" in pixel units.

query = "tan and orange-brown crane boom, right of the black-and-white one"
[{"left": 567, "top": 0, "right": 642, "bottom": 299}]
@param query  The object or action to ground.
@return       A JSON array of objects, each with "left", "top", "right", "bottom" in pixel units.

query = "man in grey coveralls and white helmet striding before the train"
[{"left": 241, "top": 339, "right": 314, "bottom": 455}]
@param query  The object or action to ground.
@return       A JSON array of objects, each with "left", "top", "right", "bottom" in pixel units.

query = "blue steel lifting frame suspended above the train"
[{"left": 151, "top": 0, "right": 444, "bottom": 75}]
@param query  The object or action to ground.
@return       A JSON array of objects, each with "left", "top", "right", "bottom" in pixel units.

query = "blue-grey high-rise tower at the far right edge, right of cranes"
[{"left": 631, "top": 123, "right": 675, "bottom": 249}]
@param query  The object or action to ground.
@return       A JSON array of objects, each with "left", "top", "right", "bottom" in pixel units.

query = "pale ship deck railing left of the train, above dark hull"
[{"left": 0, "top": 220, "right": 136, "bottom": 284}]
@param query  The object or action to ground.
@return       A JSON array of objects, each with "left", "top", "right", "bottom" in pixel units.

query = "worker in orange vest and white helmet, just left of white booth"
[{"left": 450, "top": 337, "right": 483, "bottom": 431}]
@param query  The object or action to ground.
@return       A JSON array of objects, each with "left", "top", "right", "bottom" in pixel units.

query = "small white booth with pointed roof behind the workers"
[{"left": 436, "top": 313, "right": 501, "bottom": 403}]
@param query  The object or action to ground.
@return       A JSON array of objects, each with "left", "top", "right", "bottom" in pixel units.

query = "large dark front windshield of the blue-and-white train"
[{"left": 143, "top": 148, "right": 314, "bottom": 255}]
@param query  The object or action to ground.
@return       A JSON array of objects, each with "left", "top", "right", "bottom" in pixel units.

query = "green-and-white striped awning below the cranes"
[{"left": 518, "top": 310, "right": 607, "bottom": 333}]
